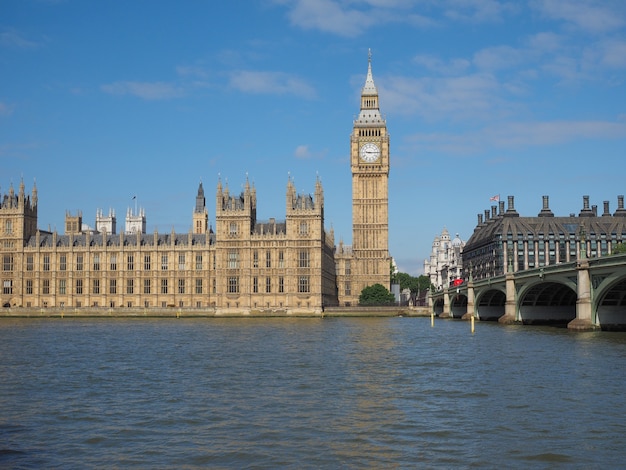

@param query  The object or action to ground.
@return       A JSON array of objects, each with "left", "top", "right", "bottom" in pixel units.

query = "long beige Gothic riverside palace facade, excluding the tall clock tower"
[{"left": 0, "top": 176, "right": 337, "bottom": 313}]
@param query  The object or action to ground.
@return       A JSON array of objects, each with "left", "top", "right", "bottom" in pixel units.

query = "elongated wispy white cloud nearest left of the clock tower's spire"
[{"left": 230, "top": 70, "right": 316, "bottom": 98}]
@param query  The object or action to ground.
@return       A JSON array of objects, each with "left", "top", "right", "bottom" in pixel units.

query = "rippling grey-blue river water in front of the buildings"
[{"left": 0, "top": 318, "right": 626, "bottom": 469}]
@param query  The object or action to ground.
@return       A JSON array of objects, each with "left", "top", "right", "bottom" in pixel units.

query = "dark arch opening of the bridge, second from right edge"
[{"left": 517, "top": 280, "right": 578, "bottom": 325}]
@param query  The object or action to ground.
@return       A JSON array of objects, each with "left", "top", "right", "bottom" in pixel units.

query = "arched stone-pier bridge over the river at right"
[{"left": 429, "top": 254, "right": 626, "bottom": 330}]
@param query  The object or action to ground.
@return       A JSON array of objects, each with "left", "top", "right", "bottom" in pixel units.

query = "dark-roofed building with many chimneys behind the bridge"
[{"left": 463, "top": 196, "right": 626, "bottom": 279}]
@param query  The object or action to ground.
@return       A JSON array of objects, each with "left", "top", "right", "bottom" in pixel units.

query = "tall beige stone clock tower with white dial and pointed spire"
[{"left": 350, "top": 52, "right": 390, "bottom": 301}]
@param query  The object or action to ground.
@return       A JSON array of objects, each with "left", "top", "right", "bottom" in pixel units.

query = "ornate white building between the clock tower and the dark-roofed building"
[{"left": 424, "top": 227, "right": 465, "bottom": 289}]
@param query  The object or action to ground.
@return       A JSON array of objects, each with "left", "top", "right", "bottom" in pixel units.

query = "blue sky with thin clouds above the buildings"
[{"left": 0, "top": 0, "right": 626, "bottom": 275}]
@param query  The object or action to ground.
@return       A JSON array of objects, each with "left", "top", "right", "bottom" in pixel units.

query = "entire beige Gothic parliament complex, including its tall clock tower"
[{"left": 0, "top": 56, "right": 390, "bottom": 314}]
